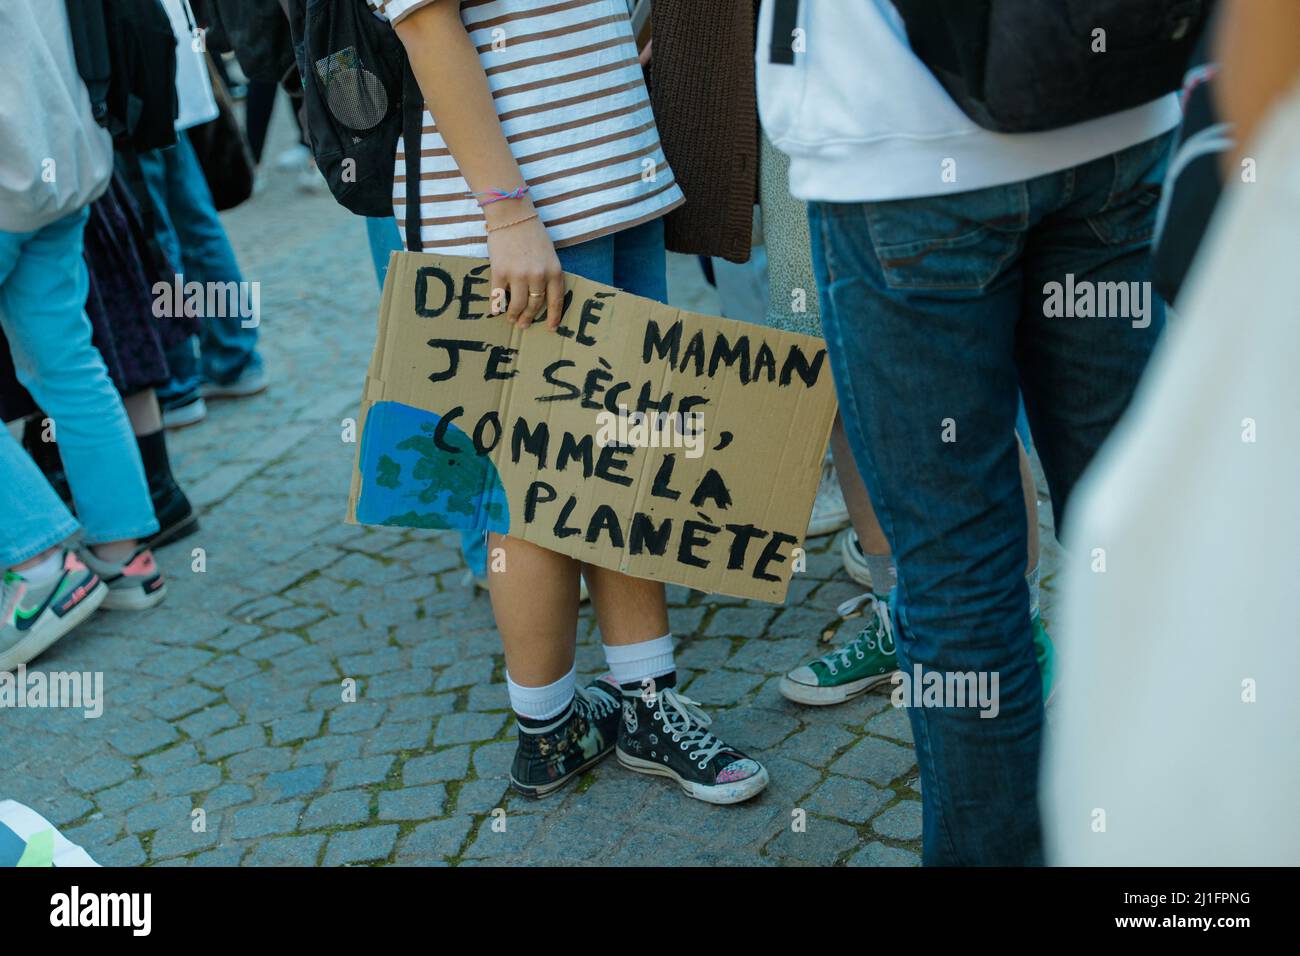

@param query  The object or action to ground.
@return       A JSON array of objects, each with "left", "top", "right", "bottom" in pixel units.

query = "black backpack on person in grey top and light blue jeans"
[{"left": 66, "top": 0, "right": 178, "bottom": 151}]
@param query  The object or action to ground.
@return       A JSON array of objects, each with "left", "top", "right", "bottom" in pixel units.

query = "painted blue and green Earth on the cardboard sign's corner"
[{"left": 356, "top": 402, "right": 510, "bottom": 535}]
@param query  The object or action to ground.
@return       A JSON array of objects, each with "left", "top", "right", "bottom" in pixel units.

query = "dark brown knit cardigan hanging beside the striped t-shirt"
[{"left": 650, "top": 0, "right": 758, "bottom": 263}]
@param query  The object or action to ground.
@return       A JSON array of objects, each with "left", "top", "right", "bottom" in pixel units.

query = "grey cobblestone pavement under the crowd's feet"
[{"left": 0, "top": 113, "right": 1052, "bottom": 866}]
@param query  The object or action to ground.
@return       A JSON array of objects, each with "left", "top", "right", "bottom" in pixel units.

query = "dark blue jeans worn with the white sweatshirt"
[{"left": 810, "top": 135, "right": 1170, "bottom": 865}]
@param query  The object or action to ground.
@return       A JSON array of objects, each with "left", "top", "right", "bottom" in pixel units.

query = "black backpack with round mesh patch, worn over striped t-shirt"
[{"left": 289, "top": 0, "right": 424, "bottom": 248}]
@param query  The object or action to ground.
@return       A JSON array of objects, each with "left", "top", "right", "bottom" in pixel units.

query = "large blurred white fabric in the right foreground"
[{"left": 1043, "top": 76, "right": 1300, "bottom": 865}]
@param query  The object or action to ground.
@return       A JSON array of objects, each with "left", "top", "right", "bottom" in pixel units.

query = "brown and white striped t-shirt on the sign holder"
[{"left": 368, "top": 0, "right": 684, "bottom": 256}]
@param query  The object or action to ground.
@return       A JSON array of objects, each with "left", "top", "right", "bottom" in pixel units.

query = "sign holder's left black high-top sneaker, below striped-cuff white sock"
[{"left": 510, "top": 680, "right": 619, "bottom": 799}]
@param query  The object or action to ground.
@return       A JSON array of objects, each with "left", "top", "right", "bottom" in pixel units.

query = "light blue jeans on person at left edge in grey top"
[{"left": 0, "top": 209, "right": 159, "bottom": 570}]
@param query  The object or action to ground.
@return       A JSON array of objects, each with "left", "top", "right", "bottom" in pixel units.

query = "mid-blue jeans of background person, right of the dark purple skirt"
[{"left": 140, "top": 131, "right": 261, "bottom": 405}]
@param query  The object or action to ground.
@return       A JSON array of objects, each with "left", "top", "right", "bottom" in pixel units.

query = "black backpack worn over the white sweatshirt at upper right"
[{"left": 889, "top": 0, "right": 1214, "bottom": 133}]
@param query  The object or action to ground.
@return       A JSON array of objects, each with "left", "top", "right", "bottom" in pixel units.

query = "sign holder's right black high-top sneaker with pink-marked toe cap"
[{"left": 618, "top": 688, "right": 767, "bottom": 804}]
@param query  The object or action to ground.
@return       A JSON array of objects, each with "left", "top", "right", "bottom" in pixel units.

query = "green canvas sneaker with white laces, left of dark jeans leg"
[{"left": 780, "top": 594, "right": 898, "bottom": 706}]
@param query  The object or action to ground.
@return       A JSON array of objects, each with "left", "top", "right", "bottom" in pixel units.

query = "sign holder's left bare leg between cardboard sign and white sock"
[{"left": 488, "top": 533, "right": 579, "bottom": 687}]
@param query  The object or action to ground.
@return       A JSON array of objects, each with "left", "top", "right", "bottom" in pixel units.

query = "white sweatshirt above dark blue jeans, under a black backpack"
[{"left": 757, "top": 0, "right": 1182, "bottom": 203}]
